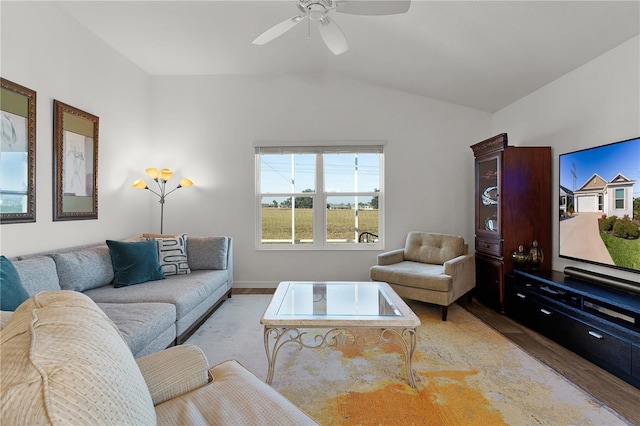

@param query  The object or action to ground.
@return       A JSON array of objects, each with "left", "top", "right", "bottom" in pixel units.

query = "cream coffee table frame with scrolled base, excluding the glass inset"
[{"left": 260, "top": 281, "right": 420, "bottom": 388}]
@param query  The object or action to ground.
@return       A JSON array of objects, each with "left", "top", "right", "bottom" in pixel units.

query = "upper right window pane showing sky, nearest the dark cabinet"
[{"left": 324, "top": 154, "right": 380, "bottom": 192}]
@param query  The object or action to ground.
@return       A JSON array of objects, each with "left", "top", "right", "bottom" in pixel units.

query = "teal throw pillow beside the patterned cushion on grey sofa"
[{"left": 107, "top": 240, "right": 164, "bottom": 288}]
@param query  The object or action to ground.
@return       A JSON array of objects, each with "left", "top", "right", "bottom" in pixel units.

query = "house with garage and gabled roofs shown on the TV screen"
[{"left": 573, "top": 173, "right": 636, "bottom": 218}]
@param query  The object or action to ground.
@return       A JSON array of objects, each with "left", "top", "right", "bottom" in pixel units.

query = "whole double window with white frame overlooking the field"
[{"left": 255, "top": 144, "right": 384, "bottom": 250}]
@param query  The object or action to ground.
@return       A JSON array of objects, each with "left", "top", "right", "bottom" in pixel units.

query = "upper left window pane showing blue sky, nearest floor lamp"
[{"left": 260, "top": 154, "right": 316, "bottom": 193}]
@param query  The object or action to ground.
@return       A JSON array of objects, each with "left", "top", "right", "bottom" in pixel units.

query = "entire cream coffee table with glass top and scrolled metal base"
[{"left": 260, "top": 281, "right": 420, "bottom": 387}]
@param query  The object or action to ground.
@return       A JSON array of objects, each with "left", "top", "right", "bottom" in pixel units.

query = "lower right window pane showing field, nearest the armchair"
[{"left": 327, "top": 196, "right": 379, "bottom": 243}]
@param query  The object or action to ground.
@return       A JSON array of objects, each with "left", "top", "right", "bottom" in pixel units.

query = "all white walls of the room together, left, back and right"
[{"left": 10, "top": 2, "right": 640, "bottom": 285}]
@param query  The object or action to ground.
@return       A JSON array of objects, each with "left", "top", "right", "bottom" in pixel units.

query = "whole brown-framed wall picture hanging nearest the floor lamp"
[{"left": 53, "top": 100, "right": 99, "bottom": 221}]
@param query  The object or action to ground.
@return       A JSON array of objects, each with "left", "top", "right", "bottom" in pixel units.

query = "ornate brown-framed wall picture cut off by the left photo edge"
[{"left": 0, "top": 78, "right": 36, "bottom": 224}]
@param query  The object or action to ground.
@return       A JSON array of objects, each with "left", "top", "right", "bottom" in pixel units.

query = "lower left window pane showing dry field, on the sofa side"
[{"left": 262, "top": 197, "right": 313, "bottom": 244}]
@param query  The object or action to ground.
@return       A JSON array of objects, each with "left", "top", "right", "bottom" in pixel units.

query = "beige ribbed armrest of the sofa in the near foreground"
[{"left": 136, "top": 345, "right": 209, "bottom": 405}]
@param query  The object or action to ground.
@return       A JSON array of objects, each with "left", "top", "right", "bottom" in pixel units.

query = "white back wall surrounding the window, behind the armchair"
[{"left": 152, "top": 75, "right": 491, "bottom": 287}]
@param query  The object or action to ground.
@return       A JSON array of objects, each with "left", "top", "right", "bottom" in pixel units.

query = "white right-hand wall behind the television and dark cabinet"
[{"left": 492, "top": 37, "right": 640, "bottom": 281}]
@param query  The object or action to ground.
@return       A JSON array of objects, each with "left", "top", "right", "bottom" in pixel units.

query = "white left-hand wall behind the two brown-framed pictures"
[{"left": 0, "top": 2, "right": 151, "bottom": 256}]
